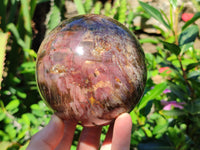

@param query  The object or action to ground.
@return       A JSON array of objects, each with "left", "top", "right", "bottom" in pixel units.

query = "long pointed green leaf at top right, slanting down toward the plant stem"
[{"left": 139, "top": 1, "right": 170, "bottom": 29}]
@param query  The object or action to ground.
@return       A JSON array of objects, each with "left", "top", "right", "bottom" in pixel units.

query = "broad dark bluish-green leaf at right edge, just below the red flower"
[{"left": 178, "top": 25, "right": 199, "bottom": 46}]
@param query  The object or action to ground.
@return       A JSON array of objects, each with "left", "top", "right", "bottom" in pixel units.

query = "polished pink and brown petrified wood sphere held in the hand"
[{"left": 36, "top": 15, "right": 146, "bottom": 126}]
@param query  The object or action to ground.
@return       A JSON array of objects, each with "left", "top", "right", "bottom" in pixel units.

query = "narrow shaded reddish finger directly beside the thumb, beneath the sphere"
[{"left": 56, "top": 121, "right": 76, "bottom": 150}]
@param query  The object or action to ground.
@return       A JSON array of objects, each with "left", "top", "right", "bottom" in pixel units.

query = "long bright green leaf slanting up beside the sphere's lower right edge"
[{"left": 138, "top": 82, "right": 167, "bottom": 110}]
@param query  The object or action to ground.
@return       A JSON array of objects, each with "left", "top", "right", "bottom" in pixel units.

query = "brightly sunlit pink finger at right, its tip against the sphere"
[{"left": 112, "top": 113, "right": 132, "bottom": 150}]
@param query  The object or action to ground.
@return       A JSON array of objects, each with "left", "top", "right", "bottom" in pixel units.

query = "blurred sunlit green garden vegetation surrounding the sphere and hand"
[{"left": 0, "top": 0, "right": 200, "bottom": 150}]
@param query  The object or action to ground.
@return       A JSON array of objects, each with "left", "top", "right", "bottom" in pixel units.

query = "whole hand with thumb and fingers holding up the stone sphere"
[{"left": 27, "top": 113, "right": 132, "bottom": 150}]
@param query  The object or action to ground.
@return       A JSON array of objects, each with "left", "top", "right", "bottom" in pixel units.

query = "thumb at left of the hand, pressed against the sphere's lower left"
[{"left": 27, "top": 115, "right": 64, "bottom": 150}]
